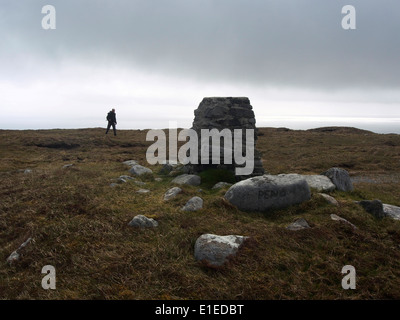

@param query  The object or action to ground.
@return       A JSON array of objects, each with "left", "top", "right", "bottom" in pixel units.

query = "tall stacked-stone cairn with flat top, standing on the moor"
[{"left": 189, "top": 97, "right": 264, "bottom": 181}]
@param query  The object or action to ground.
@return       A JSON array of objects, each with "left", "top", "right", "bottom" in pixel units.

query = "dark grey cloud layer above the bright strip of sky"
[{"left": 0, "top": 0, "right": 400, "bottom": 90}]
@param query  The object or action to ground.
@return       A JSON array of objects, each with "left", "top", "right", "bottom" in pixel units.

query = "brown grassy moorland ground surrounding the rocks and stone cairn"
[{"left": 0, "top": 128, "right": 400, "bottom": 299}]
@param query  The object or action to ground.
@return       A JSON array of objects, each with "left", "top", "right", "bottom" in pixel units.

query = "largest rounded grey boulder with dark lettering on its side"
[{"left": 225, "top": 174, "right": 311, "bottom": 212}]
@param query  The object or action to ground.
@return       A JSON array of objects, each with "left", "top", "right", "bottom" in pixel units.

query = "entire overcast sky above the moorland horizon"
[{"left": 0, "top": 0, "right": 400, "bottom": 133}]
